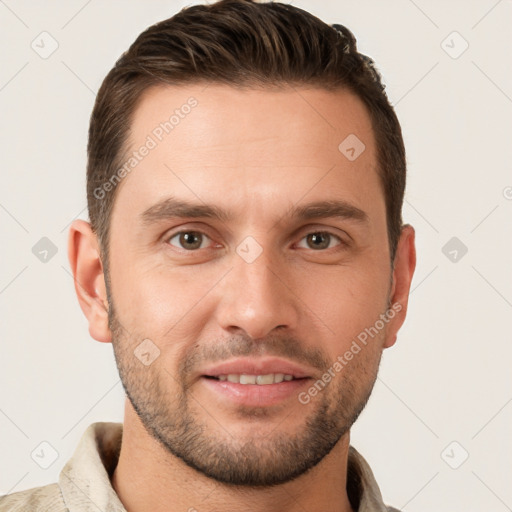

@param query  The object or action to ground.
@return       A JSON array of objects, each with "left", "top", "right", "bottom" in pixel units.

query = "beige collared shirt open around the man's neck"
[{"left": 0, "top": 422, "right": 396, "bottom": 512}]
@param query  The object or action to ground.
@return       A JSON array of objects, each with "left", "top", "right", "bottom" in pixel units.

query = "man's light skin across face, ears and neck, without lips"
[{"left": 69, "top": 84, "right": 415, "bottom": 512}]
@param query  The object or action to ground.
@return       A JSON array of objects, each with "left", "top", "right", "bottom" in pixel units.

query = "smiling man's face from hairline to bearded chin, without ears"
[{"left": 109, "top": 85, "right": 397, "bottom": 485}]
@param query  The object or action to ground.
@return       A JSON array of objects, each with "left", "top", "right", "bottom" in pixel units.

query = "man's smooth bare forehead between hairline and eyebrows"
[{"left": 114, "top": 84, "right": 380, "bottom": 222}]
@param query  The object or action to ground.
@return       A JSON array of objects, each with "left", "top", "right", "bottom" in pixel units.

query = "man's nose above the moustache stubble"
[{"left": 217, "top": 247, "right": 300, "bottom": 339}]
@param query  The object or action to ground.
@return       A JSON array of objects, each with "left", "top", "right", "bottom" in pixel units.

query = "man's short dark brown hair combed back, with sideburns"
[{"left": 87, "top": 0, "right": 406, "bottom": 267}]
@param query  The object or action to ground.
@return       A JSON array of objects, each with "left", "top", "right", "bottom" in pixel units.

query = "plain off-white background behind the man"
[{"left": 0, "top": 0, "right": 512, "bottom": 512}]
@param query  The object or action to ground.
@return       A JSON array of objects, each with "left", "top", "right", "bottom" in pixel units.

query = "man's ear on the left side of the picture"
[{"left": 68, "top": 220, "right": 112, "bottom": 343}]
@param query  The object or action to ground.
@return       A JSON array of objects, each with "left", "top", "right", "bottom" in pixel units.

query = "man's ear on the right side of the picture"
[{"left": 384, "top": 224, "right": 416, "bottom": 348}]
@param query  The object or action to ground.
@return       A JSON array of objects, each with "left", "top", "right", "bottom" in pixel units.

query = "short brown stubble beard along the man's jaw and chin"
[{"left": 109, "top": 303, "right": 381, "bottom": 487}]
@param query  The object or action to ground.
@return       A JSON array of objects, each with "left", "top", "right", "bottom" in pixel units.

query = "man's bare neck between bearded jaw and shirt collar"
[{"left": 112, "top": 400, "right": 352, "bottom": 512}]
